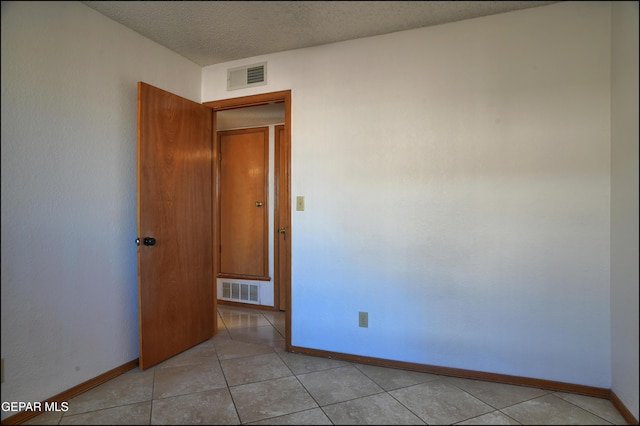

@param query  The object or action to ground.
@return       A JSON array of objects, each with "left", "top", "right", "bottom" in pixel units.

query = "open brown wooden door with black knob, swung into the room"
[{"left": 137, "top": 82, "right": 217, "bottom": 369}]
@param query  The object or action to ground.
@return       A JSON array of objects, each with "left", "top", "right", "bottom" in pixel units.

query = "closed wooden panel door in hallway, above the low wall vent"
[{"left": 218, "top": 127, "right": 270, "bottom": 280}]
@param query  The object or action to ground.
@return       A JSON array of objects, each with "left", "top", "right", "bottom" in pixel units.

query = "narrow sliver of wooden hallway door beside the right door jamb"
[{"left": 274, "top": 126, "right": 291, "bottom": 311}]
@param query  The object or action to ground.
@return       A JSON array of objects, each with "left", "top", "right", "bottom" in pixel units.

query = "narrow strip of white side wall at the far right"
[{"left": 611, "top": 1, "right": 640, "bottom": 419}]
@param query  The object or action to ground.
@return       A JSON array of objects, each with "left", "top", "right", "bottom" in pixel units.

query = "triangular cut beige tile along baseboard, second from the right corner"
[{"left": 446, "top": 377, "right": 549, "bottom": 409}]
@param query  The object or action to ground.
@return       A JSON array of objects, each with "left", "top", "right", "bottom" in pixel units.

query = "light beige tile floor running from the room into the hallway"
[{"left": 25, "top": 305, "right": 627, "bottom": 425}]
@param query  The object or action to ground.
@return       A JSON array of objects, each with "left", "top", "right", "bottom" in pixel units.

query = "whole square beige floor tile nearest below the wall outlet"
[{"left": 298, "top": 365, "right": 384, "bottom": 407}]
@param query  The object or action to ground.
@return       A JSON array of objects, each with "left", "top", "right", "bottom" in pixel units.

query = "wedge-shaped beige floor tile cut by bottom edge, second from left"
[{"left": 59, "top": 401, "right": 151, "bottom": 425}]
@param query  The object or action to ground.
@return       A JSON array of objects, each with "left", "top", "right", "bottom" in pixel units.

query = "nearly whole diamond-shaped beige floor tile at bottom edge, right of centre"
[{"left": 389, "top": 379, "right": 493, "bottom": 424}]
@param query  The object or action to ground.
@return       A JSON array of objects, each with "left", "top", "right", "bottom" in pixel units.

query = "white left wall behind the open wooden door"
[{"left": 2, "top": 1, "right": 201, "bottom": 419}]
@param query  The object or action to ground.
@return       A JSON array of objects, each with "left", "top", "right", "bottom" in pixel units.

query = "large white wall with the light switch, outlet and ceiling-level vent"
[{"left": 202, "top": 2, "right": 611, "bottom": 388}]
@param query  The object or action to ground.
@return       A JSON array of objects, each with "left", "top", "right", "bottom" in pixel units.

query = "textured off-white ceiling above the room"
[{"left": 82, "top": 1, "right": 557, "bottom": 66}]
